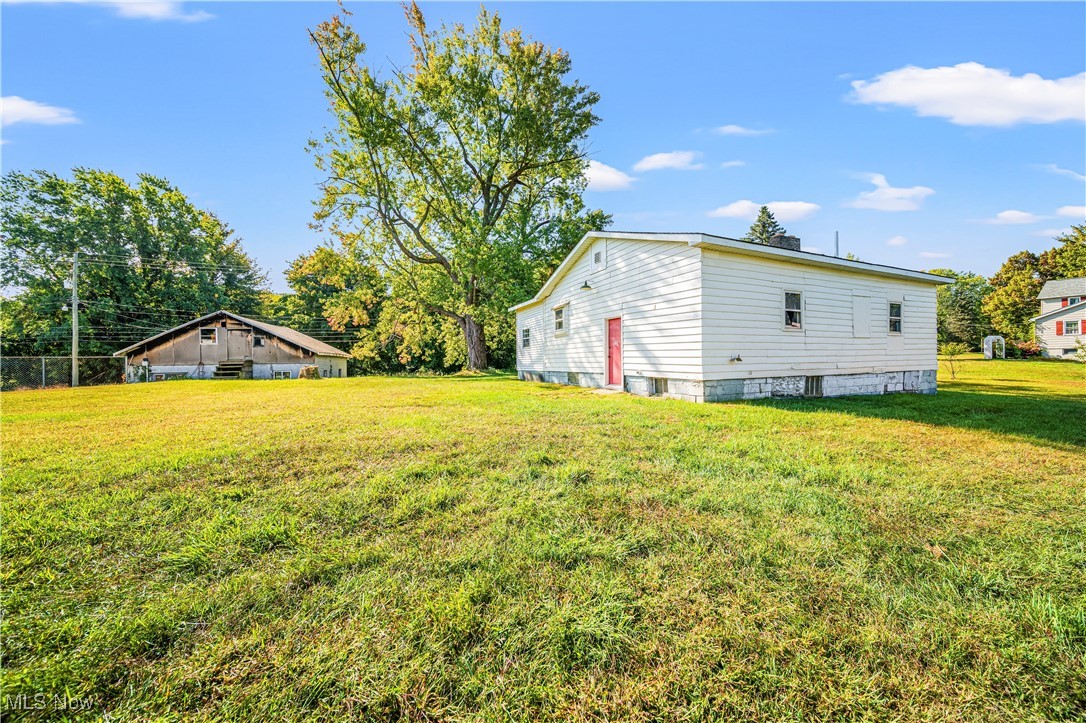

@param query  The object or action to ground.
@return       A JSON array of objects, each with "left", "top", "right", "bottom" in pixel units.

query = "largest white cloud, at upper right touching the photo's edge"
[{"left": 849, "top": 63, "right": 1086, "bottom": 126}]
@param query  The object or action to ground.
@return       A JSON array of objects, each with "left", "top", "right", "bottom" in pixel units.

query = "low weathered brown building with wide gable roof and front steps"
[{"left": 113, "top": 312, "right": 350, "bottom": 381}]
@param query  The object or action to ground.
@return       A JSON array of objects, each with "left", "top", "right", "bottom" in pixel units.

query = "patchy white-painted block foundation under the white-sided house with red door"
[{"left": 518, "top": 369, "right": 936, "bottom": 402}]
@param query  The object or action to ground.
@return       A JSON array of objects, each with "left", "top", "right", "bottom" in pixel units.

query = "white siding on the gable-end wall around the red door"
[{"left": 517, "top": 239, "right": 702, "bottom": 379}]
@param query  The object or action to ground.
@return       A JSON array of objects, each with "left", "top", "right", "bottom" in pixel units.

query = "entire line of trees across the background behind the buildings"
[{"left": 0, "top": 4, "right": 1086, "bottom": 372}]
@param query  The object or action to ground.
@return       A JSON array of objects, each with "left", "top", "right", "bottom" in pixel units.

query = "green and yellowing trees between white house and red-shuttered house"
[{"left": 932, "top": 226, "right": 1086, "bottom": 348}]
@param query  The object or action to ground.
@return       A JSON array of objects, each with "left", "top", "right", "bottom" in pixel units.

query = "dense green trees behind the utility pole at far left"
[{"left": 0, "top": 168, "right": 264, "bottom": 355}]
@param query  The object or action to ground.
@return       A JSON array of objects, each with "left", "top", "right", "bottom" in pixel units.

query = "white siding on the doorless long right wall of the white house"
[{"left": 702, "top": 250, "right": 936, "bottom": 380}]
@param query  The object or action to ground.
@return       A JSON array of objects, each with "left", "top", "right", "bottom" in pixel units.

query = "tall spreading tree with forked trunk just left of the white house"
[{"left": 311, "top": 4, "right": 607, "bottom": 369}]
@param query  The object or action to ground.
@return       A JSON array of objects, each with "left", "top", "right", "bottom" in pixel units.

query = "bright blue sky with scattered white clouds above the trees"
[{"left": 0, "top": 1, "right": 1086, "bottom": 291}]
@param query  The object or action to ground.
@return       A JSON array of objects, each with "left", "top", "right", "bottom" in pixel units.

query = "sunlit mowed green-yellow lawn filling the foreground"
[{"left": 2, "top": 360, "right": 1086, "bottom": 721}]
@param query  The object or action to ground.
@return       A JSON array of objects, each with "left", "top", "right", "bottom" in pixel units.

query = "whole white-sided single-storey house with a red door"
[{"left": 513, "top": 232, "right": 952, "bottom": 402}]
